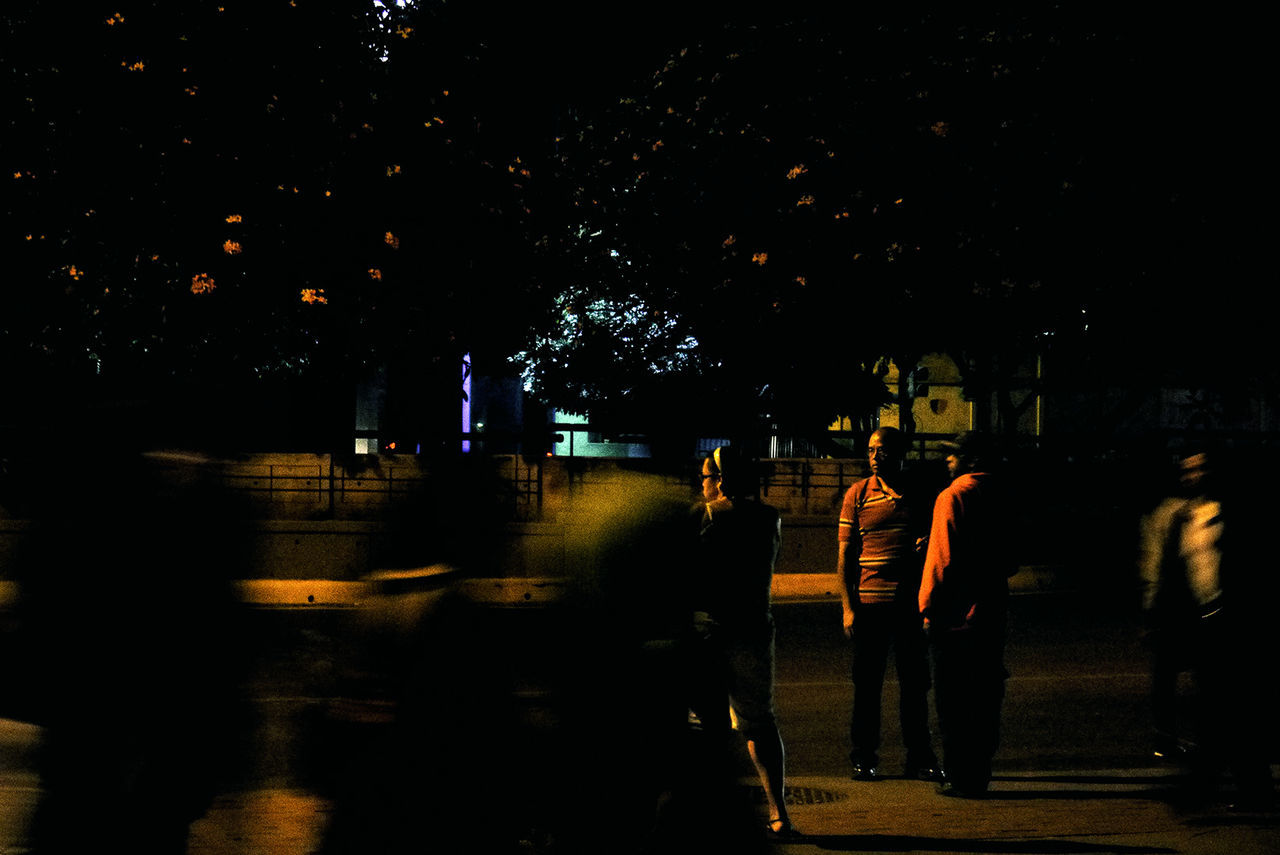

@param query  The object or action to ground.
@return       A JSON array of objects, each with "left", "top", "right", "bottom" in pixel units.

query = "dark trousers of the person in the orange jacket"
[{"left": 929, "top": 625, "right": 1009, "bottom": 792}]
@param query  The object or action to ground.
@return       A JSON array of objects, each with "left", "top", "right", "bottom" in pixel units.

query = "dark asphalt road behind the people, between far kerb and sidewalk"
[{"left": 220, "top": 591, "right": 1172, "bottom": 785}]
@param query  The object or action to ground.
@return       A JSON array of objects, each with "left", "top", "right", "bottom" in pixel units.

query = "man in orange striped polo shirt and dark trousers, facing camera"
[{"left": 836, "top": 428, "right": 942, "bottom": 781}]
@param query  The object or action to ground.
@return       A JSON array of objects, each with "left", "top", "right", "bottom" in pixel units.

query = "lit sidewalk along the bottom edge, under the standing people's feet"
[{"left": 180, "top": 769, "right": 1280, "bottom": 855}]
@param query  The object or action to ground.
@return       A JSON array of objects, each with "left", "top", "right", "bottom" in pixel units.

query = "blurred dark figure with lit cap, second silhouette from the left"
[{"left": 308, "top": 566, "right": 525, "bottom": 855}]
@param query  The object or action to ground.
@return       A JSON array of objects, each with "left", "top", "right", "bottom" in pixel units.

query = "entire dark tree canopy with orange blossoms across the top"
[{"left": 0, "top": 0, "right": 1270, "bottom": 444}]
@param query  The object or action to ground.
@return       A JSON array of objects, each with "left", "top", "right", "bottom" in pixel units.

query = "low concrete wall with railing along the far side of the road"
[{"left": 0, "top": 454, "right": 865, "bottom": 593}]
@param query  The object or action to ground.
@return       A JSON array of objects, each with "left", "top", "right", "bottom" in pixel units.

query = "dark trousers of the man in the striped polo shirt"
[{"left": 849, "top": 598, "right": 937, "bottom": 767}]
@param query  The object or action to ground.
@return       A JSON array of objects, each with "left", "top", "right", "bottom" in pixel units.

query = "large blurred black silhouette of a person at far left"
[{"left": 8, "top": 435, "right": 248, "bottom": 855}]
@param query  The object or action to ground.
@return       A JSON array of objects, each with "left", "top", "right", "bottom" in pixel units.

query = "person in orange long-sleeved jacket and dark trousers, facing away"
[{"left": 919, "top": 431, "right": 1016, "bottom": 797}]
